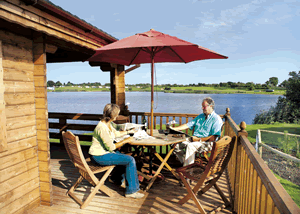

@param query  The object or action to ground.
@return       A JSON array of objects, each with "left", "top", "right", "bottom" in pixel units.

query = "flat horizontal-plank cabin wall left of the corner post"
[{"left": 0, "top": 30, "right": 41, "bottom": 213}]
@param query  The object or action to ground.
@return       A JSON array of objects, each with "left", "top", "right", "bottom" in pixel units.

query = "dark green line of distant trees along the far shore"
[{"left": 47, "top": 77, "right": 287, "bottom": 90}]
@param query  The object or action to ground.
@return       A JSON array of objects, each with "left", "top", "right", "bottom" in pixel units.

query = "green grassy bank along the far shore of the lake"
[{"left": 48, "top": 86, "right": 285, "bottom": 95}]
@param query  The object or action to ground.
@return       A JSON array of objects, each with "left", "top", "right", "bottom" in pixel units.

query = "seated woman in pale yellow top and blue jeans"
[{"left": 89, "top": 104, "right": 144, "bottom": 198}]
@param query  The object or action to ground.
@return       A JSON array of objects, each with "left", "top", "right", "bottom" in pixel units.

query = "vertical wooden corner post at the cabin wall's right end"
[{"left": 33, "top": 33, "right": 55, "bottom": 206}]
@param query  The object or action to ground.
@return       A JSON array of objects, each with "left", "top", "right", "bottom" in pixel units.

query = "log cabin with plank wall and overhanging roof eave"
[{"left": 0, "top": 0, "right": 117, "bottom": 213}]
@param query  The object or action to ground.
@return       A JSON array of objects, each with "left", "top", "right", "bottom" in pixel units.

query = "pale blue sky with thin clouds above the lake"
[{"left": 47, "top": 0, "right": 300, "bottom": 85}]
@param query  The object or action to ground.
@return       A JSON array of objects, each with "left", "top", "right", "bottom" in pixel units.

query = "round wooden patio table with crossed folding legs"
[{"left": 129, "top": 130, "right": 186, "bottom": 191}]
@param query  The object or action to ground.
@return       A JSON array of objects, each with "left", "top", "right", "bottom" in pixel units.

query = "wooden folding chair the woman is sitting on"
[{"left": 62, "top": 131, "right": 115, "bottom": 209}]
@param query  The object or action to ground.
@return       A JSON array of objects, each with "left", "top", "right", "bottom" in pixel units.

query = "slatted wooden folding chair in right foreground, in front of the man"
[{"left": 176, "top": 136, "right": 234, "bottom": 214}]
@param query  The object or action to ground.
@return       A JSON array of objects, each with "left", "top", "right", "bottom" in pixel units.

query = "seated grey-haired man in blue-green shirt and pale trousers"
[{"left": 170, "top": 97, "right": 223, "bottom": 166}]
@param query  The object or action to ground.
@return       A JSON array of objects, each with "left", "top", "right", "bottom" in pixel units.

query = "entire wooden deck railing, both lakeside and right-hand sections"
[{"left": 49, "top": 109, "right": 300, "bottom": 214}]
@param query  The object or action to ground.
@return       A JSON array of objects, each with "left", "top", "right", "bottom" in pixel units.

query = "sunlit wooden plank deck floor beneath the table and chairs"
[{"left": 28, "top": 145, "right": 232, "bottom": 214}]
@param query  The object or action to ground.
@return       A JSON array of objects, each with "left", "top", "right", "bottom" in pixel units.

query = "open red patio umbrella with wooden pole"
[{"left": 87, "top": 29, "right": 228, "bottom": 135}]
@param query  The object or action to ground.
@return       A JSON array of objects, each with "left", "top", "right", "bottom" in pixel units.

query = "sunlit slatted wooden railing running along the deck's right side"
[{"left": 225, "top": 111, "right": 300, "bottom": 214}]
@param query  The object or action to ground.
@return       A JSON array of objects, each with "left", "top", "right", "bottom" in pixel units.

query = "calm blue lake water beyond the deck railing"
[{"left": 48, "top": 92, "right": 279, "bottom": 124}]
